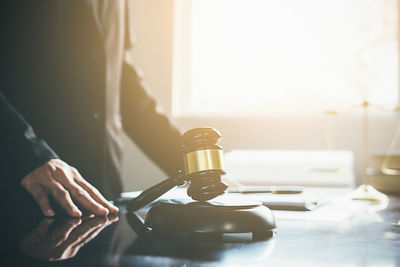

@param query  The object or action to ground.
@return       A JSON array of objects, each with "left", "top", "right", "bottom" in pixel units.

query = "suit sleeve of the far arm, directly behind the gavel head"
[{"left": 121, "top": 62, "right": 183, "bottom": 176}]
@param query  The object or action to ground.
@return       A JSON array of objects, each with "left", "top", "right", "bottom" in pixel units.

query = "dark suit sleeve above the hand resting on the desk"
[{"left": 0, "top": 91, "right": 58, "bottom": 186}]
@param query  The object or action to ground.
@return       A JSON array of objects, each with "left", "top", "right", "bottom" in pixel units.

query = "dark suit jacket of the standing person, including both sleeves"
[{"left": 0, "top": 0, "right": 182, "bottom": 201}]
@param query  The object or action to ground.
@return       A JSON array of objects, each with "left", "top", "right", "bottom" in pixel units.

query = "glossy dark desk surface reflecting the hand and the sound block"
[{"left": 0, "top": 191, "right": 400, "bottom": 266}]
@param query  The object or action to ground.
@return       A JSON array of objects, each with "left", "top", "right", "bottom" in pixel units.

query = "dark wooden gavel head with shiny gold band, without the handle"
[{"left": 182, "top": 127, "right": 228, "bottom": 201}]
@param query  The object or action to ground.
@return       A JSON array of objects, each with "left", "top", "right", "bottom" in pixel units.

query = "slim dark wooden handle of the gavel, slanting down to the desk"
[{"left": 127, "top": 173, "right": 183, "bottom": 211}]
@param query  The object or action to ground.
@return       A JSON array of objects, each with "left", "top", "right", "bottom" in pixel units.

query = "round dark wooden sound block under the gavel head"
[{"left": 145, "top": 199, "right": 276, "bottom": 239}]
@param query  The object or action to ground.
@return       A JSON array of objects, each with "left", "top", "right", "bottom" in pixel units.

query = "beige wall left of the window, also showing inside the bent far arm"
[{"left": 122, "top": 0, "right": 173, "bottom": 191}]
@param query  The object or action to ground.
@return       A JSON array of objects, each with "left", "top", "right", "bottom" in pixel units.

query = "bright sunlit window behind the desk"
[{"left": 172, "top": 0, "right": 399, "bottom": 116}]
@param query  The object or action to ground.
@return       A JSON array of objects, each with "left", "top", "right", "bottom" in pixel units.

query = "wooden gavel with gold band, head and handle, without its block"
[{"left": 127, "top": 127, "right": 228, "bottom": 211}]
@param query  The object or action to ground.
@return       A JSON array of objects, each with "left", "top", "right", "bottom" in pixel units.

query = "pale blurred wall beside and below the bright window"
[{"left": 123, "top": 0, "right": 399, "bottom": 191}]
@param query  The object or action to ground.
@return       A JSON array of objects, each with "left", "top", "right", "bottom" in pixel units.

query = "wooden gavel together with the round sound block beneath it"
[{"left": 127, "top": 127, "right": 276, "bottom": 239}]
